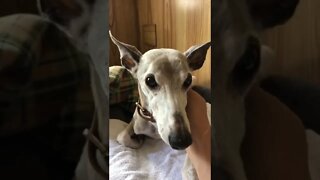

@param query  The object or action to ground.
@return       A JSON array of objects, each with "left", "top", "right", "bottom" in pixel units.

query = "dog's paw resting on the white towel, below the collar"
[{"left": 117, "top": 131, "right": 145, "bottom": 149}]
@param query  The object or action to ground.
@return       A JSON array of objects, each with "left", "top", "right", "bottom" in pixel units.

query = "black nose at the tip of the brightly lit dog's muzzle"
[{"left": 169, "top": 132, "right": 192, "bottom": 150}]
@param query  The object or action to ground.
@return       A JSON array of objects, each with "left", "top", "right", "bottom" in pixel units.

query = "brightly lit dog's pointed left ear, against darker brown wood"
[{"left": 109, "top": 31, "right": 142, "bottom": 73}]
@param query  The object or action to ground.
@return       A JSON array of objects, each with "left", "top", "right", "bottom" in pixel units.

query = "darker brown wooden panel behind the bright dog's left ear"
[{"left": 109, "top": 0, "right": 139, "bottom": 66}]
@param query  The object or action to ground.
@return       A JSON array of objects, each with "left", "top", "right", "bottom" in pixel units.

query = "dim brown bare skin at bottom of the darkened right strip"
[{"left": 242, "top": 86, "right": 310, "bottom": 180}]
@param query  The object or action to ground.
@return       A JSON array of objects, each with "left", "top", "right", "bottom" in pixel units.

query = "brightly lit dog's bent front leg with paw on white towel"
[{"left": 117, "top": 112, "right": 145, "bottom": 149}]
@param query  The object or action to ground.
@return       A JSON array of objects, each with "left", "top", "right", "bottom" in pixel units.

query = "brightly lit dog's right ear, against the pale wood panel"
[{"left": 184, "top": 42, "right": 211, "bottom": 70}]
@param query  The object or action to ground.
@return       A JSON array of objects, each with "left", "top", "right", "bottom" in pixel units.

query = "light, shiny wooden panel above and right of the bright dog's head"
[{"left": 137, "top": 0, "right": 211, "bottom": 87}]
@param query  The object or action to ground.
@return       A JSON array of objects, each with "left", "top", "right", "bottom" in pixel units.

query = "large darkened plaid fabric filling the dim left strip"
[{"left": 0, "top": 14, "right": 94, "bottom": 179}]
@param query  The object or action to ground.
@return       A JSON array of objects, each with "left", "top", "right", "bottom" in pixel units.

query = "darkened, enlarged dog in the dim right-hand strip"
[{"left": 211, "top": 0, "right": 297, "bottom": 180}]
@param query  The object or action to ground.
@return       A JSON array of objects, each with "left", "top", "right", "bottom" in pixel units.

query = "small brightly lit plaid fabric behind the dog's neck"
[{"left": 109, "top": 66, "right": 139, "bottom": 113}]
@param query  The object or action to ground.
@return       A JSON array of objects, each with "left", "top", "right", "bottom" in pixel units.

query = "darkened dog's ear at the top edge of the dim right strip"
[{"left": 247, "top": 0, "right": 299, "bottom": 29}]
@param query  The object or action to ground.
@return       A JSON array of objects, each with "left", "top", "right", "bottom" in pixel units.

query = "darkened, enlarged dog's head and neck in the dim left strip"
[{"left": 37, "top": 0, "right": 109, "bottom": 180}]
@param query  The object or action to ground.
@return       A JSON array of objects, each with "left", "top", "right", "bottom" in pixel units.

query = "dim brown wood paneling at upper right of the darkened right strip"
[{"left": 263, "top": 0, "right": 320, "bottom": 84}]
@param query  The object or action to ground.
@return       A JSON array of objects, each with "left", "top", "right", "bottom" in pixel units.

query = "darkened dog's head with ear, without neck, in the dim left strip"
[{"left": 37, "top": 0, "right": 109, "bottom": 95}]
